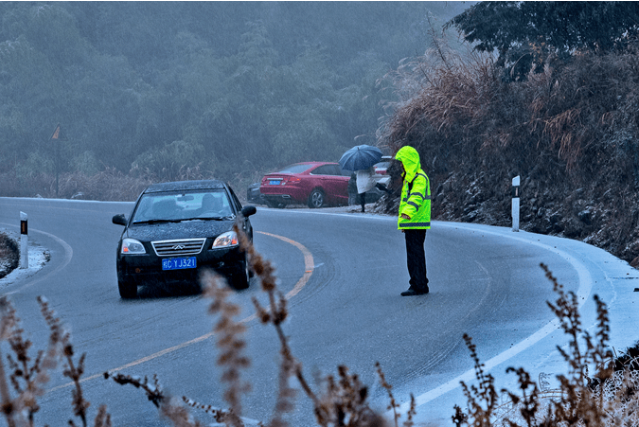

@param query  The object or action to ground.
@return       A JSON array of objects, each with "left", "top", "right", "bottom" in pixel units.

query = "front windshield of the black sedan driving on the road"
[{"left": 133, "top": 189, "right": 233, "bottom": 223}]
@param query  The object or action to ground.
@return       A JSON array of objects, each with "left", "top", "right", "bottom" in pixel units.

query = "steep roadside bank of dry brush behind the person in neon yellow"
[{"left": 384, "top": 2, "right": 639, "bottom": 266}]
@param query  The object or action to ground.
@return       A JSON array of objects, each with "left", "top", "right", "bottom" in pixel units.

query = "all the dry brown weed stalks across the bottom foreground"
[{"left": 0, "top": 227, "right": 639, "bottom": 427}]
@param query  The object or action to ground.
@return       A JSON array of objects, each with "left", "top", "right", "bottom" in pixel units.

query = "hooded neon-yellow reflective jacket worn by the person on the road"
[{"left": 395, "top": 146, "right": 430, "bottom": 230}]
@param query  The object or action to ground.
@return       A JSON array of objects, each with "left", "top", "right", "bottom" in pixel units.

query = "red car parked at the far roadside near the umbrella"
[{"left": 260, "top": 162, "right": 350, "bottom": 208}]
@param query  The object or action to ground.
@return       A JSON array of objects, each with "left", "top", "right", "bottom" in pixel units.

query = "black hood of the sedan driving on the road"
[{"left": 125, "top": 220, "right": 235, "bottom": 242}]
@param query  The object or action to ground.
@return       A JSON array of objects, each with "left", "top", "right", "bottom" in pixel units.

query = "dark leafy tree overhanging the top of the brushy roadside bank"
[{"left": 445, "top": 1, "right": 639, "bottom": 76}]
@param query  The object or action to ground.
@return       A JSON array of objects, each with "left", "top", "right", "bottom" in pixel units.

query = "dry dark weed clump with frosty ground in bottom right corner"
[{"left": 453, "top": 264, "right": 639, "bottom": 427}]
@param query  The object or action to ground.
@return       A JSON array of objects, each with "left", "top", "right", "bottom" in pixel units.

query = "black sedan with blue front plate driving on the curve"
[{"left": 113, "top": 180, "right": 256, "bottom": 298}]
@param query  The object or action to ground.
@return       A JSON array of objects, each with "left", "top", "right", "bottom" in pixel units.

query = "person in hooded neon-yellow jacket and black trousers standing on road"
[{"left": 395, "top": 146, "right": 430, "bottom": 296}]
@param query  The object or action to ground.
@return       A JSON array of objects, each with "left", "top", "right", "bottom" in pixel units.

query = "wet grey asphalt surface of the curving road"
[{"left": 0, "top": 198, "right": 578, "bottom": 426}]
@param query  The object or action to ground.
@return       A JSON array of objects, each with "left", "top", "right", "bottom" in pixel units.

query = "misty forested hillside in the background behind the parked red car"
[{"left": 0, "top": 2, "right": 468, "bottom": 198}]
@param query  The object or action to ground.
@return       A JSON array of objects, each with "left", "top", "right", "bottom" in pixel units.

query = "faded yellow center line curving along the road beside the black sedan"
[{"left": 49, "top": 231, "right": 315, "bottom": 392}]
